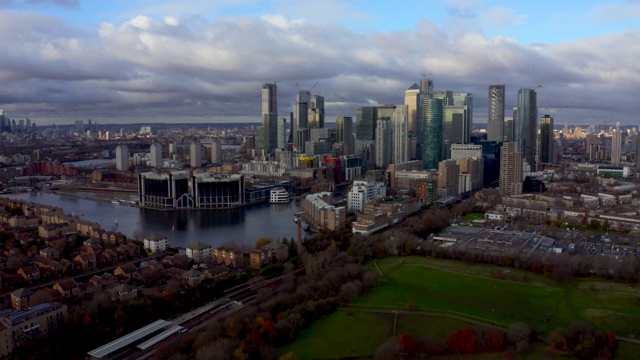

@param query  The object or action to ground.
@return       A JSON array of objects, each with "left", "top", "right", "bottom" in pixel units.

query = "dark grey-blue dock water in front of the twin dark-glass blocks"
[{"left": 4, "top": 192, "right": 301, "bottom": 247}]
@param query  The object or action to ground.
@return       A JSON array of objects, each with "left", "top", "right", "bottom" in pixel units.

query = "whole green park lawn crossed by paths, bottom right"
[{"left": 279, "top": 257, "right": 640, "bottom": 359}]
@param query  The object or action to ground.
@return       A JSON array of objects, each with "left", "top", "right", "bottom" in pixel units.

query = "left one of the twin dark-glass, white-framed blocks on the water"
[{"left": 138, "top": 170, "right": 193, "bottom": 209}]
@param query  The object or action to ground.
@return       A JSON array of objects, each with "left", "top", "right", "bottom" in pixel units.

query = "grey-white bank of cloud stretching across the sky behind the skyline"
[{"left": 0, "top": 11, "right": 640, "bottom": 122}]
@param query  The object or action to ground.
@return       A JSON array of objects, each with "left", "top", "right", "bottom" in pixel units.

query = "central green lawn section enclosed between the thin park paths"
[{"left": 360, "top": 257, "right": 565, "bottom": 327}]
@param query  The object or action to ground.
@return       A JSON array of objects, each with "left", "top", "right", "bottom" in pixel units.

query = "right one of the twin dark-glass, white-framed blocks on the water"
[{"left": 191, "top": 173, "right": 245, "bottom": 209}]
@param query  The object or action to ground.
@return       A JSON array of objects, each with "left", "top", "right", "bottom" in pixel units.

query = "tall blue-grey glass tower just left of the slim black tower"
[{"left": 514, "top": 88, "right": 538, "bottom": 169}]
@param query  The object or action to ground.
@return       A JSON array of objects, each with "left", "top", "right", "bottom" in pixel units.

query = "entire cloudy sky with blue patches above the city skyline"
[{"left": 0, "top": 0, "right": 640, "bottom": 125}]
